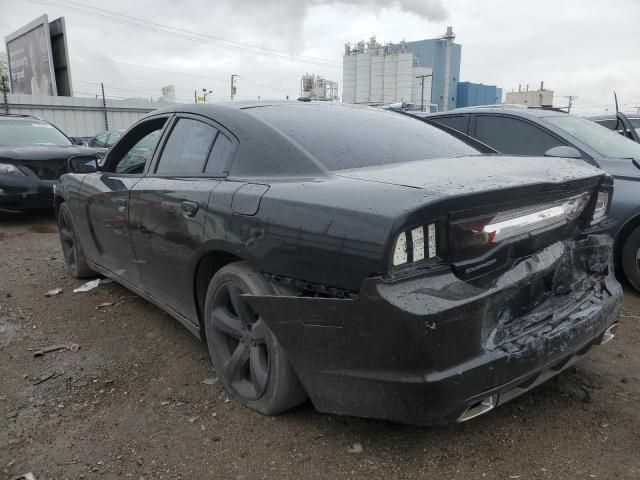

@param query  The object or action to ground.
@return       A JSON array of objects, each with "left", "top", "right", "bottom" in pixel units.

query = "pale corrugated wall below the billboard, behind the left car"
[{"left": 0, "top": 93, "right": 171, "bottom": 137}]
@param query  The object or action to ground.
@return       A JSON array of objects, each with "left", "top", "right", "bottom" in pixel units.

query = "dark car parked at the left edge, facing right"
[{"left": 0, "top": 114, "right": 105, "bottom": 212}]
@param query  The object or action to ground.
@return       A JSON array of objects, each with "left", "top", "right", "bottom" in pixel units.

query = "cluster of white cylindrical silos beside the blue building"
[{"left": 342, "top": 37, "right": 432, "bottom": 107}]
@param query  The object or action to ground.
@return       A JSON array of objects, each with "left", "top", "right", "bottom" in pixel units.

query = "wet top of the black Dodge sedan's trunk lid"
[{"left": 336, "top": 155, "right": 604, "bottom": 196}]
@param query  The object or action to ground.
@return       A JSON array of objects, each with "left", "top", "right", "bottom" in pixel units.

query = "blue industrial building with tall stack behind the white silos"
[{"left": 384, "top": 27, "right": 462, "bottom": 111}]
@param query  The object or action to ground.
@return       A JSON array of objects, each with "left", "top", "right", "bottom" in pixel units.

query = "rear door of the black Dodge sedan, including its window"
[{"left": 130, "top": 114, "right": 235, "bottom": 321}]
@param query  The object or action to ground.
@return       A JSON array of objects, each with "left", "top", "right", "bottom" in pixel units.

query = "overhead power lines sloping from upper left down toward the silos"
[{"left": 30, "top": 0, "right": 340, "bottom": 66}]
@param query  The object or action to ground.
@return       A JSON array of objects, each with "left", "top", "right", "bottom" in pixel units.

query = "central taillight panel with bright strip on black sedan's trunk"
[{"left": 450, "top": 193, "right": 590, "bottom": 256}]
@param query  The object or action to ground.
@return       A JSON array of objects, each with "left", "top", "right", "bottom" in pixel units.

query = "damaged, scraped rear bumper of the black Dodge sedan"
[{"left": 246, "top": 235, "right": 622, "bottom": 424}]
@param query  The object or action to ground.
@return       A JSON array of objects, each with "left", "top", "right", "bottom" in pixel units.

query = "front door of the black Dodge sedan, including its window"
[{"left": 79, "top": 116, "right": 168, "bottom": 285}]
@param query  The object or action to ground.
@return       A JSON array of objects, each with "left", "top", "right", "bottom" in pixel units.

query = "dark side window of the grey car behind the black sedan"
[{"left": 474, "top": 115, "right": 563, "bottom": 155}]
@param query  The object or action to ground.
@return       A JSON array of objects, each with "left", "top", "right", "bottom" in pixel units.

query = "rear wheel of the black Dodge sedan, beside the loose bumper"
[{"left": 204, "top": 262, "right": 307, "bottom": 415}]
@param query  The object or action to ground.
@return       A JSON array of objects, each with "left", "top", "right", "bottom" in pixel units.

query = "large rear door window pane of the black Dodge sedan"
[{"left": 156, "top": 118, "right": 218, "bottom": 175}]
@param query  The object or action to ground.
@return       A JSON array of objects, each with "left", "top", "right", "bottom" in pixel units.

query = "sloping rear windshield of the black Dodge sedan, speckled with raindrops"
[{"left": 245, "top": 104, "right": 479, "bottom": 171}]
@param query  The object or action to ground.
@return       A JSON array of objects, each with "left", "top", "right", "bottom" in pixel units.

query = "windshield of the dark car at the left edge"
[{"left": 0, "top": 120, "right": 71, "bottom": 147}]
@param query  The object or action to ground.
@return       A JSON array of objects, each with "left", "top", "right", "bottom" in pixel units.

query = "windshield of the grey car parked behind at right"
[{"left": 546, "top": 115, "right": 640, "bottom": 158}]
